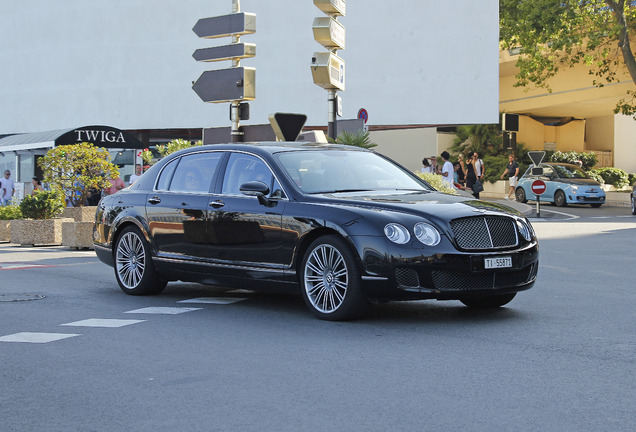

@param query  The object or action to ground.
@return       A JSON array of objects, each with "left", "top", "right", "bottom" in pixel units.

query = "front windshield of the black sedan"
[{"left": 276, "top": 150, "right": 432, "bottom": 193}]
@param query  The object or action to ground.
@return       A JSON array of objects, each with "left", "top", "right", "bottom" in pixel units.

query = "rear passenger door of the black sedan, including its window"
[{"left": 146, "top": 152, "right": 224, "bottom": 259}]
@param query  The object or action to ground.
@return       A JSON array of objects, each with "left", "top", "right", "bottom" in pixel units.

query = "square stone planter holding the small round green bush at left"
[{"left": 9, "top": 218, "right": 73, "bottom": 246}]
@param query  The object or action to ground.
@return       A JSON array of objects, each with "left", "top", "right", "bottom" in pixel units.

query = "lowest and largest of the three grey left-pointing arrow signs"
[{"left": 192, "top": 67, "right": 256, "bottom": 102}]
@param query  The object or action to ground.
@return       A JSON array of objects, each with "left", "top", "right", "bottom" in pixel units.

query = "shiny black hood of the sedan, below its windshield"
[{"left": 310, "top": 191, "right": 522, "bottom": 220}]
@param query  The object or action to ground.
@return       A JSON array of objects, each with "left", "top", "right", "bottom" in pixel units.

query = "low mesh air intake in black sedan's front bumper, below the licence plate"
[{"left": 432, "top": 263, "right": 537, "bottom": 291}]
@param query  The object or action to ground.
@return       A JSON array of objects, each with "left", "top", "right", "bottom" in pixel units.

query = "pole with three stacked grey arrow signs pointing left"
[{"left": 192, "top": 0, "right": 256, "bottom": 142}]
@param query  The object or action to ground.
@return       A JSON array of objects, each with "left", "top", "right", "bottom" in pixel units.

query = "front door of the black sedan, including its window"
[{"left": 207, "top": 152, "right": 288, "bottom": 266}]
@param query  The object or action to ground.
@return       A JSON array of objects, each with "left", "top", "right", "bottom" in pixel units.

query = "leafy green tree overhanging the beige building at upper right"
[{"left": 499, "top": 0, "right": 636, "bottom": 116}]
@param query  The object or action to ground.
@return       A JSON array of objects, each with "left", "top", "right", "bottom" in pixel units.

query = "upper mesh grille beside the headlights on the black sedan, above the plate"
[{"left": 450, "top": 216, "right": 518, "bottom": 250}]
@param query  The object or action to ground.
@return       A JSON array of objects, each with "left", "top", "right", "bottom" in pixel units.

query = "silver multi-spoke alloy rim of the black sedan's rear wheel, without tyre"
[{"left": 115, "top": 232, "right": 146, "bottom": 289}]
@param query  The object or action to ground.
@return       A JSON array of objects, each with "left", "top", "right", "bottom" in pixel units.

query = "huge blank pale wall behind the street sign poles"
[{"left": 0, "top": 0, "right": 499, "bottom": 134}]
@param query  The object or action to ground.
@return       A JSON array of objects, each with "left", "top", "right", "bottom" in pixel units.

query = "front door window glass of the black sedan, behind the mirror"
[{"left": 221, "top": 153, "right": 280, "bottom": 195}]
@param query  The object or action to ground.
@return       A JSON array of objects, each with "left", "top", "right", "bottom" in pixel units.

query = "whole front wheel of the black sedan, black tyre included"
[{"left": 300, "top": 235, "right": 369, "bottom": 321}]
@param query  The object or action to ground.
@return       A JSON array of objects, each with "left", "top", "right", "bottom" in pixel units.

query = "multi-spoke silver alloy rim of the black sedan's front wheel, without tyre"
[{"left": 304, "top": 244, "right": 349, "bottom": 313}]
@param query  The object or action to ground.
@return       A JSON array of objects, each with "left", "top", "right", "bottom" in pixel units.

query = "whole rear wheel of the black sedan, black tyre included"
[{"left": 115, "top": 226, "right": 167, "bottom": 295}]
